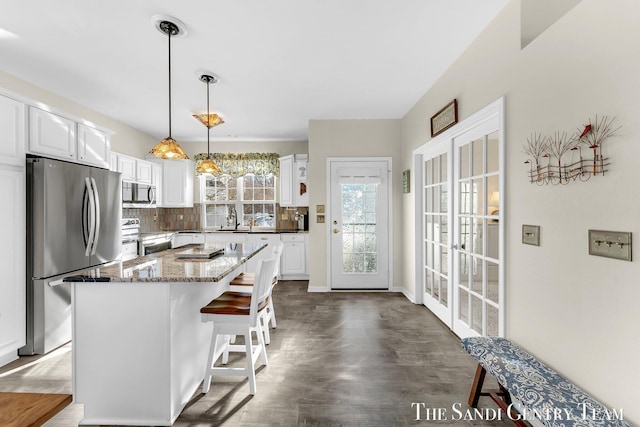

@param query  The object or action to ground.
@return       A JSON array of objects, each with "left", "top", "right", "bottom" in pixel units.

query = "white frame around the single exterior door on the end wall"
[{"left": 325, "top": 157, "right": 393, "bottom": 291}]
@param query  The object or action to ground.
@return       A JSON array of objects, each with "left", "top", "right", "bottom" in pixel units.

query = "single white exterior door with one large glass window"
[{"left": 328, "top": 159, "right": 391, "bottom": 289}]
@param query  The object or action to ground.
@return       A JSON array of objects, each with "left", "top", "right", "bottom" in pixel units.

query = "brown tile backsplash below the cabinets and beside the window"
[{"left": 122, "top": 203, "right": 309, "bottom": 233}]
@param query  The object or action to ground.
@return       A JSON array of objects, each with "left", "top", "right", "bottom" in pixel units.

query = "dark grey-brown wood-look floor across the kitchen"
[{"left": 0, "top": 281, "right": 511, "bottom": 427}]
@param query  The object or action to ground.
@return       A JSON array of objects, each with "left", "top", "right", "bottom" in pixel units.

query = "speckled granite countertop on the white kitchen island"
[{"left": 64, "top": 243, "right": 267, "bottom": 282}]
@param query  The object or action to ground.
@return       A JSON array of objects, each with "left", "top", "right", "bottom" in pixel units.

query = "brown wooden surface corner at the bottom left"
[{"left": 0, "top": 393, "right": 71, "bottom": 427}]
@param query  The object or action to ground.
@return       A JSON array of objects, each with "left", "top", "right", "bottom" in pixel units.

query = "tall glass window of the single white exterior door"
[{"left": 341, "top": 183, "right": 378, "bottom": 274}]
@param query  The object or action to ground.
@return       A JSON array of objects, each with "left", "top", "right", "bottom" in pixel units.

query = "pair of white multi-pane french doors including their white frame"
[{"left": 414, "top": 99, "right": 505, "bottom": 337}]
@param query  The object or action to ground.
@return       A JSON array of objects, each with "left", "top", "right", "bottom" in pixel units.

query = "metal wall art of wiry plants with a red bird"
[{"left": 523, "top": 116, "right": 621, "bottom": 185}]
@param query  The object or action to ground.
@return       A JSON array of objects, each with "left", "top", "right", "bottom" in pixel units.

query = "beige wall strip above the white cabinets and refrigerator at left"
[{"left": 0, "top": 71, "right": 157, "bottom": 158}]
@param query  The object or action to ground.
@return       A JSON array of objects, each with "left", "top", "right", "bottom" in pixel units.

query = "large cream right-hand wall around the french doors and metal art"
[{"left": 400, "top": 0, "right": 640, "bottom": 423}]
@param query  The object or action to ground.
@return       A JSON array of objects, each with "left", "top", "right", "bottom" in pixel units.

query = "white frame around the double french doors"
[{"left": 412, "top": 97, "right": 507, "bottom": 336}]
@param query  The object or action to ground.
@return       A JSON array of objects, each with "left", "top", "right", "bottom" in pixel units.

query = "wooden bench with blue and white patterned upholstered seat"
[{"left": 462, "top": 337, "right": 633, "bottom": 427}]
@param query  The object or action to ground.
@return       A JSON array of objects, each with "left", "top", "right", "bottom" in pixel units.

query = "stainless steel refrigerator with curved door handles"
[{"left": 19, "top": 157, "right": 122, "bottom": 355}]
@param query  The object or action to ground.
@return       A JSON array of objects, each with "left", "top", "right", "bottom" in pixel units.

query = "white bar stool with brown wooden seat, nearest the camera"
[{"left": 200, "top": 258, "right": 276, "bottom": 394}]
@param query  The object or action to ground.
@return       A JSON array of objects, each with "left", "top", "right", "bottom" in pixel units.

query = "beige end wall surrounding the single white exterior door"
[{"left": 309, "top": 120, "right": 402, "bottom": 289}]
